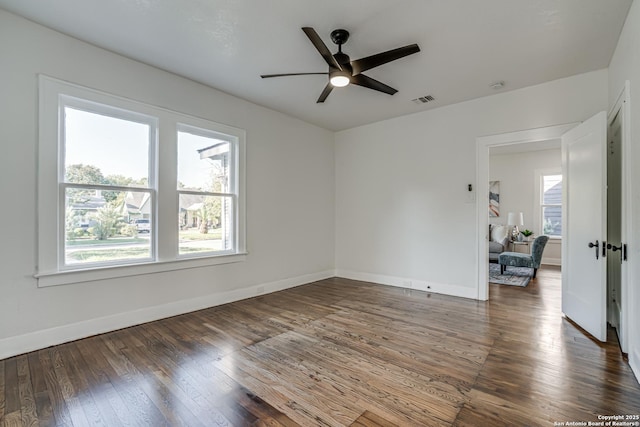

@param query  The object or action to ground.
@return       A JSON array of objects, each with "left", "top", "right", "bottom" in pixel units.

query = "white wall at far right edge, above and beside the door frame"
[{"left": 609, "top": 1, "right": 640, "bottom": 384}]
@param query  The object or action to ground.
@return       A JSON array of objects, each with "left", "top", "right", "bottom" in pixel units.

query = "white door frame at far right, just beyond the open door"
[{"left": 607, "top": 80, "right": 640, "bottom": 353}]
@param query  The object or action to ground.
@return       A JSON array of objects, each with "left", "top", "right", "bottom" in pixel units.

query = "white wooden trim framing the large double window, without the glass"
[{"left": 34, "top": 75, "right": 247, "bottom": 287}]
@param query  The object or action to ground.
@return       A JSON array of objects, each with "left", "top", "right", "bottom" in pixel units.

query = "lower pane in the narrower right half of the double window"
[{"left": 178, "top": 194, "right": 233, "bottom": 255}]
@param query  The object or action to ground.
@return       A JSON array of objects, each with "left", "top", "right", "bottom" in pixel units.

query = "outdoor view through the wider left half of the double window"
[{"left": 63, "top": 106, "right": 153, "bottom": 265}]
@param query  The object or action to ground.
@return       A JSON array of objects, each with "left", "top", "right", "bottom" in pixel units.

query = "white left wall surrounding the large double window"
[{"left": 0, "top": 10, "right": 334, "bottom": 358}]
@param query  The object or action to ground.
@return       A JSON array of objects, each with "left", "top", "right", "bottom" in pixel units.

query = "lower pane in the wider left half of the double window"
[{"left": 64, "top": 188, "right": 152, "bottom": 265}]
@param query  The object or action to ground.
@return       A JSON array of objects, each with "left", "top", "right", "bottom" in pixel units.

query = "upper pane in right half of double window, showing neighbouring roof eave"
[{"left": 178, "top": 131, "right": 231, "bottom": 193}]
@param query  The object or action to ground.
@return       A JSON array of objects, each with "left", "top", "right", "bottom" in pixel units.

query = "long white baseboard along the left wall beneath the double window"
[{"left": 0, "top": 270, "right": 335, "bottom": 360}]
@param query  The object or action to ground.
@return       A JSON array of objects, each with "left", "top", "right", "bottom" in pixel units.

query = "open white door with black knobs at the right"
[{"left": 562, "top": 111, "right": 607, "bottom": 341}]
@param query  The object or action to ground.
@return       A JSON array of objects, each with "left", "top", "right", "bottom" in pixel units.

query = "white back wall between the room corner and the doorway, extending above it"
[{"left": 335, "top": 70, "right": 607, "bottom": 297}]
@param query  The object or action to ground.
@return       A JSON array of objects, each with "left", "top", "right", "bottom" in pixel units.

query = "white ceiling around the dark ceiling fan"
[{"left": 0, "top": 0, "right": 632, "bottom": 130}]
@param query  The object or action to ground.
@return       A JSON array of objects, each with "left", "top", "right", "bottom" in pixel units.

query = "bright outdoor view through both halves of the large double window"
[{"left": 62, "top": 106, "right": 235, "bottom": 265}]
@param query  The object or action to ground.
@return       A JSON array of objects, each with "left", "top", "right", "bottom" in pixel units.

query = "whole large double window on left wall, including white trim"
[{"left": 36, "top": 76, "right": 244, "bottom": 286}]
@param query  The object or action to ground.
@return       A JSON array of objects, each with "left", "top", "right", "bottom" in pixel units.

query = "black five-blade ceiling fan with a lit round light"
[{"left": 260, "top": 27, "right": 420, "bottom": 103}]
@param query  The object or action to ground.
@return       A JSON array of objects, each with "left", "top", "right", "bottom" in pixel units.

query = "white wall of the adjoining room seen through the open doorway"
[{"left": 489, "top": 148, "right": 562, "bottom": 265}]
